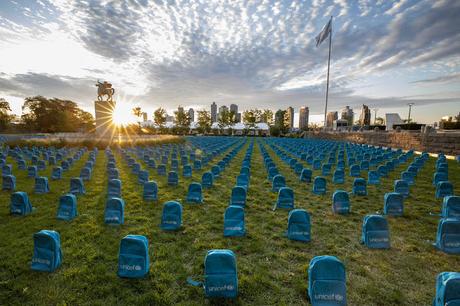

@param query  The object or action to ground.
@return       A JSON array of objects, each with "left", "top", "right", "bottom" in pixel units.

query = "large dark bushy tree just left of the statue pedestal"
[{"left": 21, "top": 96, "right": 94, "bottom": 133}]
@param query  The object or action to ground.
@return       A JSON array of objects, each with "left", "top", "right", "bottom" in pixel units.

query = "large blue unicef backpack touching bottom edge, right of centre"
[{"left": 308, "top": 255, "right": 347, "bottom": 306}]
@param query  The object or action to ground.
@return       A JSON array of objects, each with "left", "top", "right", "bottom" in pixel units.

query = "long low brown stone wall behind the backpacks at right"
[{"left": 306, "top": 131, "right": 460, "bottom": 156}]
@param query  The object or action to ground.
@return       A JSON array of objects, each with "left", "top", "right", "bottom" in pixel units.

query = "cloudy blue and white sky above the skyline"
[{"left": 0, "top": 0, "right": 460, "bottom": 123}]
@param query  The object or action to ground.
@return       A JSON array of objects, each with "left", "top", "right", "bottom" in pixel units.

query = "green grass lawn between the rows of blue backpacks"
[{"left": 0, "top": 140, "right": 460, "bottom": 305}]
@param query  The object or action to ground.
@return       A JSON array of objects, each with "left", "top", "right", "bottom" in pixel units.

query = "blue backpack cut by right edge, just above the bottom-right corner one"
[{"left": 434, "top": 218, "right": 460, "bottom": 254}]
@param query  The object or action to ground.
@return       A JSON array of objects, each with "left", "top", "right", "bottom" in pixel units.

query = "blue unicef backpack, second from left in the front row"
[{"left": 117, "top": 235, "right": 150, "bottom": 278}]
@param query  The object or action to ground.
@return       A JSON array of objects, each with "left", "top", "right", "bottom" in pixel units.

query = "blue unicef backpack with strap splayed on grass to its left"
[{"left": 187, "top": 250, "right": 238, "bottom": 298}]
